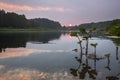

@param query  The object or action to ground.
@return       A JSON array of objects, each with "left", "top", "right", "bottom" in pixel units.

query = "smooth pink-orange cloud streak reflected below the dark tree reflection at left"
[{"left": 0, "top": 48, "right": 65, "bottom": 59}]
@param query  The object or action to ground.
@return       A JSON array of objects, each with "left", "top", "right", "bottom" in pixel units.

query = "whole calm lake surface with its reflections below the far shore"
[{"left": 0, "top": 32, "right": 120, "bottom": 80}]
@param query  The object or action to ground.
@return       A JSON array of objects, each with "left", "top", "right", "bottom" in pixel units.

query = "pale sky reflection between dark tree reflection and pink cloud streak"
[{"left": 26, "top": 34, "right": 79, "bottom": 51}]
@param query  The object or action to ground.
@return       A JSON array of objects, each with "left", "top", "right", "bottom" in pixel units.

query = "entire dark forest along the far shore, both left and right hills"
[{"left": 0, "top": 10, "right": 120, "bottom": 36}]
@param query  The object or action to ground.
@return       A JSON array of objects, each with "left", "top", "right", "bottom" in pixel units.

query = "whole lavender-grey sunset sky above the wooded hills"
[{"left": 0, "top": 0, "right": 120, "bottom": 26}]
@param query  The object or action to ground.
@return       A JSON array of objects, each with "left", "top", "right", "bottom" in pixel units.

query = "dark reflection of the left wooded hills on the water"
[{"left": 0, "top": 32, "right": 61, "bottom": 52}]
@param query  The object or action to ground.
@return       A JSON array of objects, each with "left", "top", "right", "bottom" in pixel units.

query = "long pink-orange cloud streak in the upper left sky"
[{"left": 0, "top": 2, "right": 70, "bottom": 12}]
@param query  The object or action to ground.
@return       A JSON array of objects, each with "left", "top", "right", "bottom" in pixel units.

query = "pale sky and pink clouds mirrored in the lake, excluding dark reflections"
[{"left": 0, "top": 35, "right": 120, "bottom": 80}]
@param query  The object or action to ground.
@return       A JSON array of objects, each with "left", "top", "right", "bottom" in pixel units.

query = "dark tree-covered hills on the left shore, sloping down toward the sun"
[{"left": 0, "top": 10, "right": 61, "bottom": 29}]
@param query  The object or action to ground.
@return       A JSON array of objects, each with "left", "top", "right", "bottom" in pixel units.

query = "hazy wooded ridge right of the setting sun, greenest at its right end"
[{"left": 69, "top": 19, "right": 120, "bottom": 36}]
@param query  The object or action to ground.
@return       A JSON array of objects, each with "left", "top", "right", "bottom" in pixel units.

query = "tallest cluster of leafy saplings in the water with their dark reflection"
[{"left": 70, "top": 28, "right": 97, "bottom": 79}]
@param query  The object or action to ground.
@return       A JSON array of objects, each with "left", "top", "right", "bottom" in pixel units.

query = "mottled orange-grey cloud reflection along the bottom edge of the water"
[{"left": 0, "top": 69, "right": 78, "bottom": 80}]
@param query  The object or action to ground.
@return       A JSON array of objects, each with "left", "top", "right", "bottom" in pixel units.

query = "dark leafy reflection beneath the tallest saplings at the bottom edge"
[{"left": 70, "top": 57, "right": 97, "bottom": 79}]
